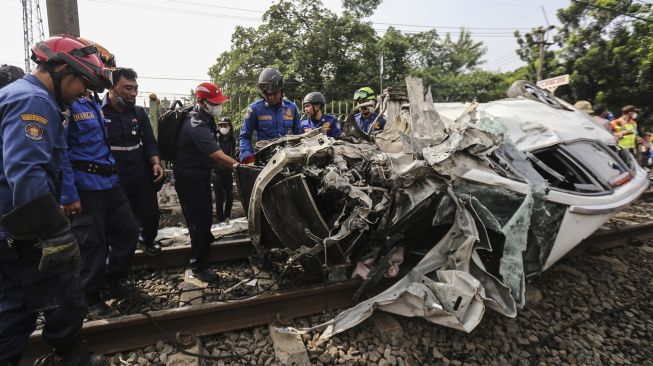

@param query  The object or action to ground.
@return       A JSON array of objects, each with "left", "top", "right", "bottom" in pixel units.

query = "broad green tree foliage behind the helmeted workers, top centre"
[{"left": 209, "top": 0, "right": 505, "bottom": 106}]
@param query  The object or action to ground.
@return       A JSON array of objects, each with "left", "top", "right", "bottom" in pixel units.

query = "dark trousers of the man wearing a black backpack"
[{"left": 174, "top": 171, "right": 213, "bottom": 271}]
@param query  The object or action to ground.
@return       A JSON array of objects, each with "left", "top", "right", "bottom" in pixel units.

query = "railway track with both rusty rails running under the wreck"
[{"left": 21, "top": 222, "right": 653, "bottom": 365}]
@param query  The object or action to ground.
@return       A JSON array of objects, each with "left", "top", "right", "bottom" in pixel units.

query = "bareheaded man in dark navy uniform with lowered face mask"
[{"left": 102, "top": 68, "right": 164, "bottom": 256}]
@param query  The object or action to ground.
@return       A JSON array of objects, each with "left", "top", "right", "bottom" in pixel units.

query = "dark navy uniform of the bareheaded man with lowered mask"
[{"left": 102, "top": 95, "right": 159, "bottom": 246}]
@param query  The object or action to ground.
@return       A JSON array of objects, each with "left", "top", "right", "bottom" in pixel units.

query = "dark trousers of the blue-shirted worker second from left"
[{"left": 71, "top": 186, "right": 140, "bottom": 304}]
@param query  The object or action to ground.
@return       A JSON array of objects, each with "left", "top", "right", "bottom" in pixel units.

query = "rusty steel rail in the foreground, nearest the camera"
[{"left": 21, "top": 280, "right": 391, "bottom": 365}]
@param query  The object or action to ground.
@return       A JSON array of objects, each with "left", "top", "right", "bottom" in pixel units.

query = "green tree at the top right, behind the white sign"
[{"left": 558, "top": 0, "right": 653, "bottom": 111}]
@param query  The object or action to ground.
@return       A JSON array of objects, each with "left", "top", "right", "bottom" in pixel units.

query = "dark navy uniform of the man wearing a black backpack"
[{"left": 173, "top": 106, "right": 220, "bottom": 272}]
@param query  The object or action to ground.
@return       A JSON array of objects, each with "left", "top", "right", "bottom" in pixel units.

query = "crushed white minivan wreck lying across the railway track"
[{"left": 237, "top": 78, "right": 648, "bottom": 337}]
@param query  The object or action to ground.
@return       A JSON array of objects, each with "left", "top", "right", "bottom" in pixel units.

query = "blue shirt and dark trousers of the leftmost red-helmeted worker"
[{"left": 0, "top": 75, "right": 86, "bottom": 361}]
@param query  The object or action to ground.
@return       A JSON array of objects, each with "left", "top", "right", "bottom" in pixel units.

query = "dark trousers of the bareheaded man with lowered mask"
[{"left": 120, "top": 174, "right": 159, "bottom": 245}]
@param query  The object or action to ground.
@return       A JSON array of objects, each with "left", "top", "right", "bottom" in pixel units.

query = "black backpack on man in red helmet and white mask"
[{"left": 157, "top": 100, "right": 193, "bottom": 161}]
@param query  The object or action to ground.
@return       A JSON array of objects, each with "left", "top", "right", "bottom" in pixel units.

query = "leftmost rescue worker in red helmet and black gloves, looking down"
[{"left": 0, "top": 35, "right": 110, "bottom": 365}]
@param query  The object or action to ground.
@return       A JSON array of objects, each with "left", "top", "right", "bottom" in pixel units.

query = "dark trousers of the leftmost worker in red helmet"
[{"left": 0, "top": 242, "right": 87, "bottom": 364}]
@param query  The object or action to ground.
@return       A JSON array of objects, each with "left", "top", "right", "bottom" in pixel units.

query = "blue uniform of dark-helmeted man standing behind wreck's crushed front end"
[{"left": 240, "top": 98, "right": 302, "bottom": 161}]
